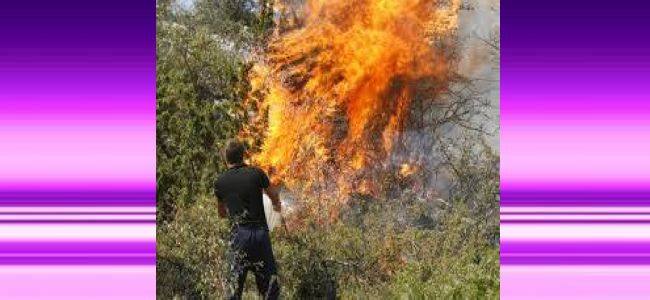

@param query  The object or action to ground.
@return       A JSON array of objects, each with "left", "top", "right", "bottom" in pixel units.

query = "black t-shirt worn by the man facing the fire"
[{"left": 214, "top": 165, "right": 269, "bottom": 227}]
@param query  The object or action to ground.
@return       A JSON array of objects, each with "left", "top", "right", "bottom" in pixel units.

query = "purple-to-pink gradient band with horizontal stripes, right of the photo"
[{"left": 500, "top": 0, "right": 650, "bottom": 299}]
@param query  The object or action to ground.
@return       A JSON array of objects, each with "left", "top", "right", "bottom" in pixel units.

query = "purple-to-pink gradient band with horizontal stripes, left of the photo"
[{"left": 0, "top": 0, "right": 156, "bottom": 299}]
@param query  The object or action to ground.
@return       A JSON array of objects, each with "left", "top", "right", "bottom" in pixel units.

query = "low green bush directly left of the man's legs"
[{"left": 156, "top": 198, "right": 228, "bottom": 299}]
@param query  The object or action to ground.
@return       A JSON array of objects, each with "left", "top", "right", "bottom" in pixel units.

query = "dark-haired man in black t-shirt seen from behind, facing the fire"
[{"left": 214, "top": 139, "right": 281, "bottom": 299}]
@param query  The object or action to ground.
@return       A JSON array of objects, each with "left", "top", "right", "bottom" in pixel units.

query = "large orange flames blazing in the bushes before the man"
[{"left": 244, "top": 0, "right": 460, "bottom": 206}]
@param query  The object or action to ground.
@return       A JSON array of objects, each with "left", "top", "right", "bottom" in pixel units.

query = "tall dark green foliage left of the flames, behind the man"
[{"left": 156, "top": 0, "right": 268, "bottom": 222}]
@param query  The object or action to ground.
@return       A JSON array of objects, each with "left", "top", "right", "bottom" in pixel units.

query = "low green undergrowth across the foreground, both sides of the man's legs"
[{"left": 158, "top": 138, "right": 499, "bottom": 299}]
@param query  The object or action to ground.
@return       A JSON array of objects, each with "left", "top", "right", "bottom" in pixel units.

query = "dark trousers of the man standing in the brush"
[{"left": 229, "top": 225, "right": 280, "bottom": 299}]
